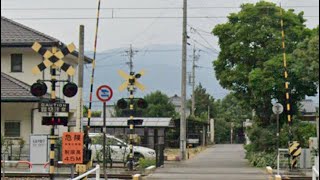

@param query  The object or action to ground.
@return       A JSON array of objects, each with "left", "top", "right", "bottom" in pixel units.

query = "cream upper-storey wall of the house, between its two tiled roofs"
[{"left": 1, "top": 48, "right": 78, "bottom": 112}]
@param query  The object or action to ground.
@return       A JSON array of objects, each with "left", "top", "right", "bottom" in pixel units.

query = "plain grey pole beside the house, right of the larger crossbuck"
[{"left": 74, "top": 25, "right": 84, "bottom": 132}]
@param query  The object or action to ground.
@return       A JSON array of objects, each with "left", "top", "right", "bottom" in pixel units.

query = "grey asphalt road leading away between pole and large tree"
[{"left": 145, "top": 145, "right": 267, "bottom": 180}]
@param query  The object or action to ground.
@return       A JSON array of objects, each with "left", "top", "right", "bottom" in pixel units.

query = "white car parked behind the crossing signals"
[{"left": 89, "top": 133, "right": 156, "bottom": 163}]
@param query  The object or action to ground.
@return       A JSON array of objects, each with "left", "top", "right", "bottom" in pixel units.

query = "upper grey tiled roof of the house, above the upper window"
[{"left": 1, "top": 16, "right": 59, "bottom": 46}]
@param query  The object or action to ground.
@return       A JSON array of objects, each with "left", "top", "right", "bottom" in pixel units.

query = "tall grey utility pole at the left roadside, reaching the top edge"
[{"left": 180, "top": 0, "right": 187, "bottom": 160}]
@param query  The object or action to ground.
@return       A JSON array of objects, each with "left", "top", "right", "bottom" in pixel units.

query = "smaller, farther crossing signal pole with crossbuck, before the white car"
[{"left": 117, "top": 68, "right": 147, "bottom": 171}]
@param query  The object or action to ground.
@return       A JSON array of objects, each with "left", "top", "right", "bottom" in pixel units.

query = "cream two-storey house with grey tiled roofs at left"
[{"left": 1, "top": 16, "right": 91, "bottom": 143}]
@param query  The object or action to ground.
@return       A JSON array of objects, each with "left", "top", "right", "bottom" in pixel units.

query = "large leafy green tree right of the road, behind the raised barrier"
[{"left": 213, "top": 1, "right": 316, "bottom": 125}]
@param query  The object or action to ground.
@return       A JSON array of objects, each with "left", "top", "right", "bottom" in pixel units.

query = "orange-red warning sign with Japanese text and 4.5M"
[{"left": 62, "top": 132, "right": 83, "bottom": 164}]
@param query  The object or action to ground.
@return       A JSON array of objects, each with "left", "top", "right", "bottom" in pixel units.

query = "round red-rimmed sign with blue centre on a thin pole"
[{"left": 96, "top": 85, "right": 113, "bottom": 177}]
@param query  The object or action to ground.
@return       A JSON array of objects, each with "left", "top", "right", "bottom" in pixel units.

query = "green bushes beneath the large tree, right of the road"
[{"left": 245, "top": 120, "right": 316, "bottom": 168}]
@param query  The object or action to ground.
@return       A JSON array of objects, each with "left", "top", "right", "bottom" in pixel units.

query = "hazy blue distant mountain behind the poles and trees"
[{"left": 84, "top": 45, "right": 228, "bottom": 107}]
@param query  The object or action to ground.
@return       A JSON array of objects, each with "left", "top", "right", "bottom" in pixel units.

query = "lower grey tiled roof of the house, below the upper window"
[{"left": 1, "top": 72, "right": 50, "bottom": 102}]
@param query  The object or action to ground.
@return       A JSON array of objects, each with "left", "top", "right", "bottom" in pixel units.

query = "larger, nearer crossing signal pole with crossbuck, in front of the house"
[{"left": 30, "top": 42, "right": 78, "bottom": 179}]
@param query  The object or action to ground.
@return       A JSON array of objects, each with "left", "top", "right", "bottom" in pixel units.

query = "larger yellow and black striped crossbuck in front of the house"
[{"left": 31, "top": 42, "right": 76, "bottom": 76}]
